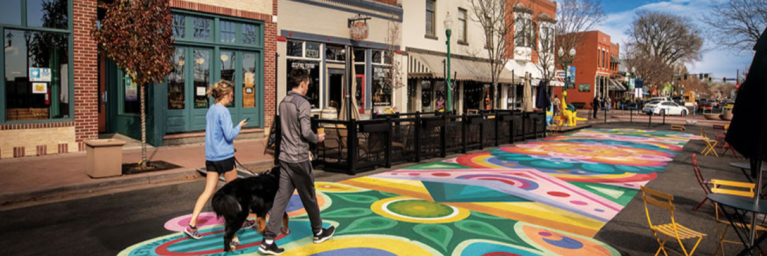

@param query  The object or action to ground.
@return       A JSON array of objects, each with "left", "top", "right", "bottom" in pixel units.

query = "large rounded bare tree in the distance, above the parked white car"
[{"left": 626, "top": 11, "right": 703, "bottom": 95}]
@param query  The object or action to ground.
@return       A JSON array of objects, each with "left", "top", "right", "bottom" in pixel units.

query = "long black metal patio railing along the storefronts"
[{"left": 312, "top": 110, "right": 546, "bottom": 175}]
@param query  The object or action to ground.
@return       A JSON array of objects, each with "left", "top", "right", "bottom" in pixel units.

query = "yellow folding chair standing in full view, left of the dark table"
[{"left": 642, "top": 186, "right": 706, "bottom": 256}]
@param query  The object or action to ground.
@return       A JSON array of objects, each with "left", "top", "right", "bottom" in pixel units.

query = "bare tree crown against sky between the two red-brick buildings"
[{"left": 554, "top": 0, "right": 607, "bottom": 64}]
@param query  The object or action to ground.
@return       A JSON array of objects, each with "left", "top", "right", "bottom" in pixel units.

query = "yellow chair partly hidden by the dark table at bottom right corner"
[{"left": 711, "top": 179, "right": 767, "bottom": 255}]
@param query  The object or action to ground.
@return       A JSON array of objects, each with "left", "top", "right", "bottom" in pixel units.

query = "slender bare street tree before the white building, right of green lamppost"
[{"left": 471, "top": 0, "right": 514, "bottom": 108}]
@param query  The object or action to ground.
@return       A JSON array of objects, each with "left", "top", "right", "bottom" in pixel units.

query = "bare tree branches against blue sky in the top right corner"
[{"left": 699, "top": 0, "right": 767, "bottom": 50}]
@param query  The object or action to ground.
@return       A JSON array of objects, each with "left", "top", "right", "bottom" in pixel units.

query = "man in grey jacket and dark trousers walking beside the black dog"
[{"left": 258, "top": 68, "right": 335, "bottom": 255}]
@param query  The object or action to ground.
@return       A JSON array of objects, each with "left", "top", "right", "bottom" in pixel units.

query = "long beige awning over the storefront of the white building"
[{"left": 407, "top": 52, "right": 522, "bottom": 84}]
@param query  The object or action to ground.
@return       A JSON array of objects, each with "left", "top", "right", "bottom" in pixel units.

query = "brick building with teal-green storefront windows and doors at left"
[{"left": 0, "top": 0, "right": 278, "bottom": 158}]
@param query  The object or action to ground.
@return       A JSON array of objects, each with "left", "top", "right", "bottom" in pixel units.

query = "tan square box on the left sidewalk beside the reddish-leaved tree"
[{"left": 85, "top": 139, "right": 125, "bottom": 178}]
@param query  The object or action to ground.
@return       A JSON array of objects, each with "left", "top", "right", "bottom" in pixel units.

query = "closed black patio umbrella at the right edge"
[{"left": 725, "top": 26, "right": 767, "bottom": 250}]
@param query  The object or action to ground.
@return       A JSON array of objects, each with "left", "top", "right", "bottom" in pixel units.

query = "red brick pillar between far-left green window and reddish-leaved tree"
[{"left": 72, "top": 0, "right": 98, "bottom": 145}]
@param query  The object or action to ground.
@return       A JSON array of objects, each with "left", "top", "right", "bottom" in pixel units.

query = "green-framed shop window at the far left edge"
[{"left": 0, "top": 0, "right": 76, "bottom": 124}]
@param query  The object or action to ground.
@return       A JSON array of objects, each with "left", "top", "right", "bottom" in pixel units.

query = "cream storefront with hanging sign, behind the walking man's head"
[{"left": 278, "top": 0, "right": 406, "bottom": 118}]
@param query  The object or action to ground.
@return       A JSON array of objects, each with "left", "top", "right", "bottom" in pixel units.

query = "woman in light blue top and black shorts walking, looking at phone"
[{"left": 184, "top": 80, "right": 250, "bottom": 239}]
